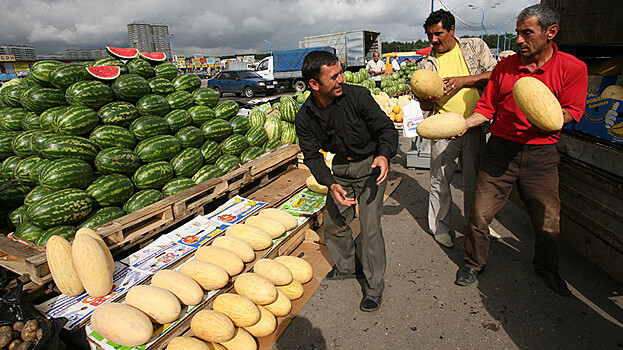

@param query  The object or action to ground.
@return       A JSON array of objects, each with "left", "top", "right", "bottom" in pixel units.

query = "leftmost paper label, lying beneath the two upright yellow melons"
[{"left": 35, "top": 261, "right": 150, "bottom": 331}]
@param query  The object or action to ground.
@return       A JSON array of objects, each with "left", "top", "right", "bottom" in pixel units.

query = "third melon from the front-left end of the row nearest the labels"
[{"left": 151, "top": 270, "right": 203, "bottom": 305}]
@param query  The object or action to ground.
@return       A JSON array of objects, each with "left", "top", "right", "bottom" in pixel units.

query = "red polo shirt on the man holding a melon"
[{"left": 474, "top": 44, "right": 588, "bottom": 145}]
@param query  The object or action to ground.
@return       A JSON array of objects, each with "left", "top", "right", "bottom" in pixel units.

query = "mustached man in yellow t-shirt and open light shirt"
[{"left": 417, "top": 10, "right": 496, "bottom": 248}]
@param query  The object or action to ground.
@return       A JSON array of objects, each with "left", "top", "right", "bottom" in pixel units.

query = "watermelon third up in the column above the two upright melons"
[{"left": 39, "top": 158, "right": 94, "bottom": 191}]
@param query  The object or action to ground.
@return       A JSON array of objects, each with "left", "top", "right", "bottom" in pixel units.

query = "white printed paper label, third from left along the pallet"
[{"left": 166, "top": 216, "right": 229, "bottom": 248}]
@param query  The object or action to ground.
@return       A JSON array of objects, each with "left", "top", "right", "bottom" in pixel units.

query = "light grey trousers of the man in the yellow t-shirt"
[{"left": 428, "top": 126, "right": 485, "bottom": 235}]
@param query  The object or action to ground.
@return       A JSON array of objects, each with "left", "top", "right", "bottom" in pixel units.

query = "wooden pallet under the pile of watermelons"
[{"left": 0, "top": 144, "right": 300, "bottom": 285}]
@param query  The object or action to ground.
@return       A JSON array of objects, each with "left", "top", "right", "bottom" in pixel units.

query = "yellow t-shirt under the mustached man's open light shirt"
[{"left": 437, "top": 43, "right": 480, "bottom": 117}]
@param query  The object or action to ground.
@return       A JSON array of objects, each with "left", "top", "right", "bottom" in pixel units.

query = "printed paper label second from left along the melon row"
[{"left": 122, "top": 236, "right": 195, "bottom": 274}]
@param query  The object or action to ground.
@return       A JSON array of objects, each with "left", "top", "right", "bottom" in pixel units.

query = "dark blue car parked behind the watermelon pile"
[{"left": 208, "top": 70, "right": 277, "bottom": 97}]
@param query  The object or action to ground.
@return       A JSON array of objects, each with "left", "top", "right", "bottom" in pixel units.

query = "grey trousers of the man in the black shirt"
[{"left": 324, "top": 156, "right": 387, "bottom": 296}]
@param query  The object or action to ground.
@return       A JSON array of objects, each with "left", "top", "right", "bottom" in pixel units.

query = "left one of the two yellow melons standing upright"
[{"left": 45, "top": 236, "right": 84, "bottom": 297}]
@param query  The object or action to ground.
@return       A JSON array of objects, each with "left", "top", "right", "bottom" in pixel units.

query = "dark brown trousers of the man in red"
[{"left": 463, "top": 136, "right": 560, "bottom": 272}]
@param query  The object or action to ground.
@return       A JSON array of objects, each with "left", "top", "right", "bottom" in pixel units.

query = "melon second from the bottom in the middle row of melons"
[{"left": 190, "top": 310, "right": 236, "bottom": 342}]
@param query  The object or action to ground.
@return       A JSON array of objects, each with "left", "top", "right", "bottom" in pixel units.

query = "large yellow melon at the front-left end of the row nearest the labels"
[{"left": 91, "top": 303, "right": 154, "bottom": 346}]
